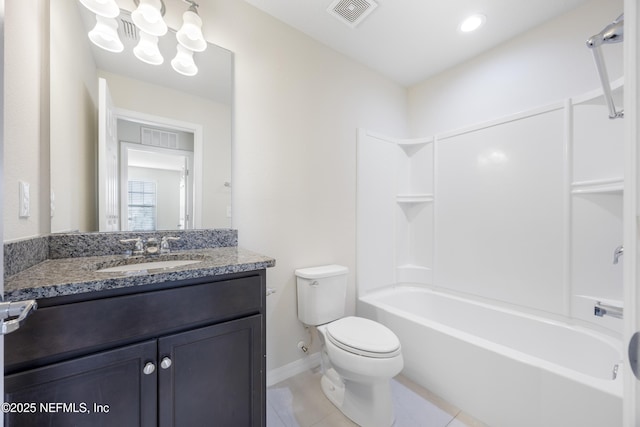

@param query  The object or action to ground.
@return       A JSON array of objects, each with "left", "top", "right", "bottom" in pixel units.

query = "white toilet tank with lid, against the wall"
[{"left": 296, "top": 264, "right": 349, "bottom": 326}]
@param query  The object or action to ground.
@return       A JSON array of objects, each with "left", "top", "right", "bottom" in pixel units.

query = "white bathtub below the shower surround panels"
[{"left": 358, "top": 285, "right": 622, "bottom": 427}]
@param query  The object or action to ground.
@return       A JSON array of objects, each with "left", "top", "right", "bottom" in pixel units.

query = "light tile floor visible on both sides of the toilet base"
[{"left": 267, "top": 370, "right": 487, "bottom": 427}]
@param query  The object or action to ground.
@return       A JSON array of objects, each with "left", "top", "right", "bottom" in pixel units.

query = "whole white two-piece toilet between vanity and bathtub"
[{"left": 295, "top": 265, "right": 403, "bottom": 427}]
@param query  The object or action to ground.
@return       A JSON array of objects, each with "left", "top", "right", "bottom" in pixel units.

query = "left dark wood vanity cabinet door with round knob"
[{"left": 3, "top": 340, "right": 157, "bottom": 427}]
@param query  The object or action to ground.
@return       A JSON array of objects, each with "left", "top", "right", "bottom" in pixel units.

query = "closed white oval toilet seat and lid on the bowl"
[{"left": 326, "top": 317, "right": 400, "bottom": 358}]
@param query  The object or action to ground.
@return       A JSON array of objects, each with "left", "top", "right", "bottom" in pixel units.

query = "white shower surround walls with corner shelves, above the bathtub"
[{"left": 357, "top": 82, "right": 623, "bottom": 336}]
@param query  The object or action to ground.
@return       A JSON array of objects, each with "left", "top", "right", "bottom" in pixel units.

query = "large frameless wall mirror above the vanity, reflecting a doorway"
[{"left": 49, "top": 0, "right": 233, "bottom": 233}]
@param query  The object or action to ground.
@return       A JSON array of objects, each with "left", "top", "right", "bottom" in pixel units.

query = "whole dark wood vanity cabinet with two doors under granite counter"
[{"left": 3, "top": 270, "right": 265, "bottom": 427}]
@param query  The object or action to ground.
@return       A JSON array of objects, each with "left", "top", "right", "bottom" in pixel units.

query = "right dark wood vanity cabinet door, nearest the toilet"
[{"left": 158, "top": 315, "right": 265, "bottom": 427}]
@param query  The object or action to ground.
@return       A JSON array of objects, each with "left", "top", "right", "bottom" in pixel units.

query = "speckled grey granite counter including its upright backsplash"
[{"left": 4, "top": 229, "right": 275, "bottom": 301}]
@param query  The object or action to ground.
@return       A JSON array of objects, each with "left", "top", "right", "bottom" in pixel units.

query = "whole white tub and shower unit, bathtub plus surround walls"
[{"left": 356, "top": 82, "right": 623, "bottom": 427}]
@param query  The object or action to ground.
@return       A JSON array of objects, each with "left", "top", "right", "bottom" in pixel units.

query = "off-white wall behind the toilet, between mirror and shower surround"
[{"left": 200, "top": 0, "right": 406, "bottom": 369}]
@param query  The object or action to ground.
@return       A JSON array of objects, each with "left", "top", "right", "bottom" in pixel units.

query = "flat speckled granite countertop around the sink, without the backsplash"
[{"left": 4, "top": 246, "right": 275, "bottom": 301}]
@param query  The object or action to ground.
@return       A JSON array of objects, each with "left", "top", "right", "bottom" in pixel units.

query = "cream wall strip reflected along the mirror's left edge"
[{"left": 47, "top": 1, "right": 98, "bottom": 233}]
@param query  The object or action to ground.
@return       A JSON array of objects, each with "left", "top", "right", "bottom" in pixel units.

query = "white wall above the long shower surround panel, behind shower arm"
[{"left": 409, "top": 0, "right": 623, "bottom": 137}]
